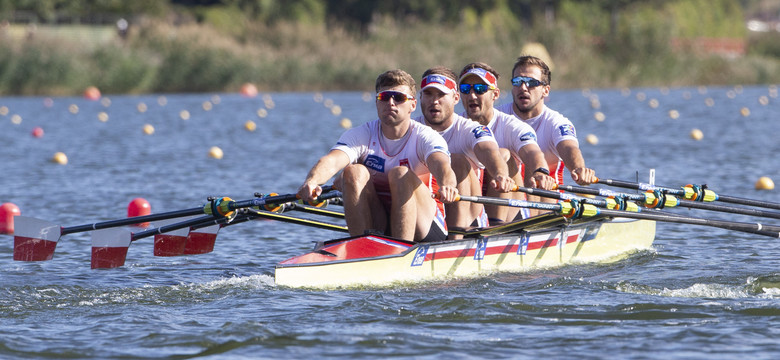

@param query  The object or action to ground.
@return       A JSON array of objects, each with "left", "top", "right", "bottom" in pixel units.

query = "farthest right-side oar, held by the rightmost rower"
[{"left": 598, "top": 179, "right": 780, "bottom": 210}]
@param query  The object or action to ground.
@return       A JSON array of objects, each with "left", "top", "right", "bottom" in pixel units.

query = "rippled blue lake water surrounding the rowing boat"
[{"left": 0, "top": 86, "right": 780, "bottom": 359}]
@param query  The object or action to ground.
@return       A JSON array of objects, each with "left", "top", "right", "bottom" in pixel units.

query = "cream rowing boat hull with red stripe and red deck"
[{"left": 276, "top": 217, "right": 655, "bottom": 288}]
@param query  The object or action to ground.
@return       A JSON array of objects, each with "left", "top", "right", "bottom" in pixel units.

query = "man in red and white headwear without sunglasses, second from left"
[{"left": 415, "top": 66, "right": 515, "bottom": 239}]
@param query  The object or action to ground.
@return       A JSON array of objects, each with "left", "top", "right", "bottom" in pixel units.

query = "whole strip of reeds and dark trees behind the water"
[{"left": 0, "top": 0, "right": 780, "bottom": 95}]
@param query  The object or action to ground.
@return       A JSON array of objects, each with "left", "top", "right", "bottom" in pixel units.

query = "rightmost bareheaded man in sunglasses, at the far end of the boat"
[{"left": 497, "top": 56, "right": 596, "bottom": 185}]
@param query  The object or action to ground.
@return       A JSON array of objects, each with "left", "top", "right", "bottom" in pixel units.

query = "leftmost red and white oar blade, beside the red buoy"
[{"left": 14, "top": 216, "right": 62, "bottom": 261}]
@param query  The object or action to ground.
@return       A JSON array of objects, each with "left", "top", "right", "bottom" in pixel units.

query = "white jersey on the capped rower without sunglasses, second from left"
[{"left": 414, "top": 114, "right": 496, "bottom": 169}]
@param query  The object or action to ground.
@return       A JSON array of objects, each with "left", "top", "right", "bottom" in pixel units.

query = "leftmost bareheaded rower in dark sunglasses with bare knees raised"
[{"left": 298, "top": 70, "right": 458, "bottom": 241}]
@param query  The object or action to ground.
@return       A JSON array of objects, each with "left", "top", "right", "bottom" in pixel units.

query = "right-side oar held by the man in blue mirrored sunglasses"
[{"left": 558, "top": 185, "right": 780, "bottom": 219}]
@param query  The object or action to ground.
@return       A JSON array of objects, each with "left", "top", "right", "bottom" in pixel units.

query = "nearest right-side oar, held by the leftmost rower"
[{"left": 450, "top": 196, "right": 780, "bottom": 238}]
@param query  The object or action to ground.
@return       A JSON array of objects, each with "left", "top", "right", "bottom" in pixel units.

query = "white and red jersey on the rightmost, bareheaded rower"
[{"left": 496, "top": 102, "right": 579, "bottom": 184}]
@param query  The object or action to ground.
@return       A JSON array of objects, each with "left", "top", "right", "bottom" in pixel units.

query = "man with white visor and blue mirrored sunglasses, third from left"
[{"left": 459, "top": 62, "right": 555, "bottom": 225}]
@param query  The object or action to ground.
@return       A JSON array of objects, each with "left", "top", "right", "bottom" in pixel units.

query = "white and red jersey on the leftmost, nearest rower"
[{"left": 331, "top": 119, "right": 449, "bottom": 197}]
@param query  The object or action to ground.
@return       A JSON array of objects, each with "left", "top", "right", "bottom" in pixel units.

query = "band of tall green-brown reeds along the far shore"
[{"left": 0, "top": 13, "right": 780, "bottom": 95}]
